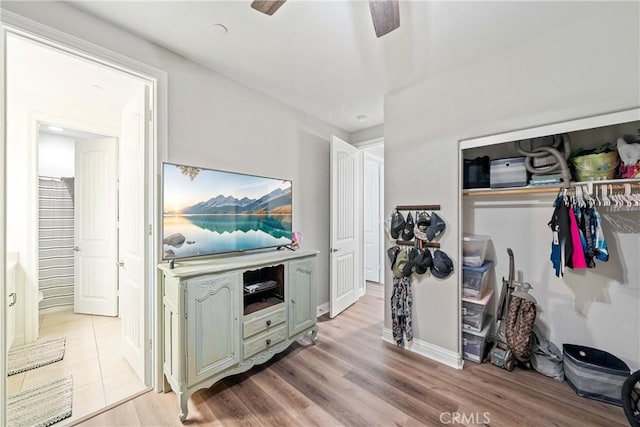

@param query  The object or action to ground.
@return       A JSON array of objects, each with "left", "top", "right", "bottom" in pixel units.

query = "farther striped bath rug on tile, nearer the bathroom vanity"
[{"left": 7, "top": 337, "right": 65, "bottom": 376}]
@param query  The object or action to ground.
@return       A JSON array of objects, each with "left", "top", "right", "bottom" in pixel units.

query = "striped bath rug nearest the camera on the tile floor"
[{"left": 7, "top": 375, "right": 73, "bottom": 427}]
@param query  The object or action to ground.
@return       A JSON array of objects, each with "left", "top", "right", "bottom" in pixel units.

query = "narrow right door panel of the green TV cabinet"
[{"left": 287, "top": 259, "right": 316, "bottom": 337}]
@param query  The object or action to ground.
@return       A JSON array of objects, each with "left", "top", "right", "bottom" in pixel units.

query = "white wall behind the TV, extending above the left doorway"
[{"left": 2, "top": 2, "right": 348, "bottom": 303}]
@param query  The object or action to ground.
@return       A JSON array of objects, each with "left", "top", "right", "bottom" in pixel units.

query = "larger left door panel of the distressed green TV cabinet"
[{"left": 187, "top": 273, "right": 241, "bottom": 386}]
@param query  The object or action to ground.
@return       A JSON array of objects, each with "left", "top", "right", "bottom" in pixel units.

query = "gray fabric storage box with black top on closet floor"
[{"left": 562, "top": 344, "right": 631, "bottom": 406}]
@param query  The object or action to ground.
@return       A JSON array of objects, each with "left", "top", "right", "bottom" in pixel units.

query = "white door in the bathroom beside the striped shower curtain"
[{"left": 74, "top": 138, "right": 118, "bottom": 316}]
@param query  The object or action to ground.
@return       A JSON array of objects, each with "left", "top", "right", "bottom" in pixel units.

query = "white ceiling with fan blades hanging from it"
[{"left": 70, "top": 0, "right": 607, "bottom": 132}]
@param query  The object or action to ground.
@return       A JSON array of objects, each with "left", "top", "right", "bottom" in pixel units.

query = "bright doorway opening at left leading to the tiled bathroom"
[{"left": 1, "top": 32, "right": 156, "bottom": 421}]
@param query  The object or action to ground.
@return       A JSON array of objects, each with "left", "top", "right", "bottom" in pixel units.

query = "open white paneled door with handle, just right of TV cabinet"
[{"left": 329, "top": 136, "right": 362, "bottom": 317}]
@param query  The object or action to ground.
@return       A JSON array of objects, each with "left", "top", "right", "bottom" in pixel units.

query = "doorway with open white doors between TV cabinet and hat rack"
[{"left": 328, "top": 136, "right": 384, "bottom": 318}]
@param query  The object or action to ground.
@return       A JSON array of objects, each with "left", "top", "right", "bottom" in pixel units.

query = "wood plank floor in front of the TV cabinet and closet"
[{"left": 74, "top": 285, "right": 627, "bottom": 427}]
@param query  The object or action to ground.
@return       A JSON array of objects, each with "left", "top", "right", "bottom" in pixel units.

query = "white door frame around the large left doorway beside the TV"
[{"left": 0, "top": 10, "right": 168, "bottom": 425}]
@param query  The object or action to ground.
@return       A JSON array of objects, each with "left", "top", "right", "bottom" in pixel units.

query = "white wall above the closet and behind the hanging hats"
[{"left": 384, "top": 2, "right": 640, "bottom": 366}]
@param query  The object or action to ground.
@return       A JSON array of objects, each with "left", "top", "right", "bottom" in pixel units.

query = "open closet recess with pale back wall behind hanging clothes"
[{"left": 460, "top": 109, "right": 640, "bottom": 372}]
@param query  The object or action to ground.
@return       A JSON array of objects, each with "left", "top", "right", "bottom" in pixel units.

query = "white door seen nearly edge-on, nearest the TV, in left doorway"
[{"left": 118, "top": 85, "right": 149, "bottom": 382}]
